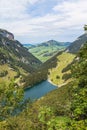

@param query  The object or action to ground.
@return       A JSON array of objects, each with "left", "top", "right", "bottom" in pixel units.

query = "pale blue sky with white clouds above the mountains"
[{"left": 0, "top": 0, "right": 87, "bottom": 43}]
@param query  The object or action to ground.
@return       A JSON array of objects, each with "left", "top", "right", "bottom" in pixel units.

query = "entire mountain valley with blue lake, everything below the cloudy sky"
[{"left": 0, "top": 29, "right": 87, "bottom": 130}]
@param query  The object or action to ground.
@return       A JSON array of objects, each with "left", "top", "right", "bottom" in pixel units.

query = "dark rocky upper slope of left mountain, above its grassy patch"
[{"left": 0, "top": 29, "right": 41, "bottom": 72}]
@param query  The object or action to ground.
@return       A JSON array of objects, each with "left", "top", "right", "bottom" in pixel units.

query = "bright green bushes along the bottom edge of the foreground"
[{"left": 0, "top": 106, "right": 69, "bottom": 130}]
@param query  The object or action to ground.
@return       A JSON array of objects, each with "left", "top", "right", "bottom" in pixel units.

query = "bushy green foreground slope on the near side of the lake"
[{"left": 0, "top": 44, "right": 87, "bottom": 130}]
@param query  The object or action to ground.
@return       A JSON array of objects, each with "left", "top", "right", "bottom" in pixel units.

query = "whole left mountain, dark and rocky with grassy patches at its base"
[{"left": 0, "top": 29, "right": 41, "bottom": 84}]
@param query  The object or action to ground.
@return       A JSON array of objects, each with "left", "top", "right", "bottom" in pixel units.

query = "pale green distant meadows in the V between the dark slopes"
[{"left": 29, "top": 46, "right": 65, "bottom": 62}]
